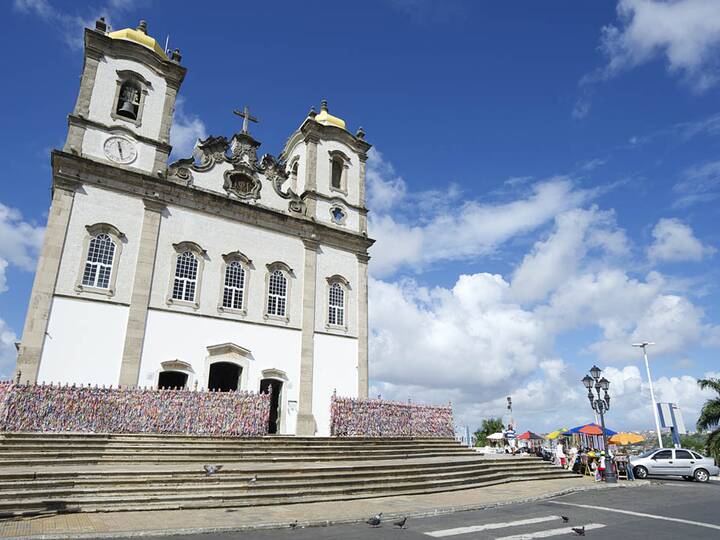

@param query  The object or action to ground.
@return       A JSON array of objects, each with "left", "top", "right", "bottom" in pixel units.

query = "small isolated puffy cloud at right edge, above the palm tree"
[{"left": 648, "top": 218, "right": 715, "bottom": 262}]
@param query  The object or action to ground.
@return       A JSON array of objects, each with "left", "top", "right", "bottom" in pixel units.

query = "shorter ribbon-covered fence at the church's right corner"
[{"left": 330, "top": 395, "right": 455, "bottom": 437}]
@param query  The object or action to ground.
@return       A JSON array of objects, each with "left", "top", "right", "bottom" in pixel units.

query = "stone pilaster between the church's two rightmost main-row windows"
[{"left": 296, "top": 239, "right": 318, "bottom": 437}]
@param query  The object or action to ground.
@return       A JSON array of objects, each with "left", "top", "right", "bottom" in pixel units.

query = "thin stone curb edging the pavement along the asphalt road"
[{"left": 2, "top": 480, "right": 651, "bottom": 540}]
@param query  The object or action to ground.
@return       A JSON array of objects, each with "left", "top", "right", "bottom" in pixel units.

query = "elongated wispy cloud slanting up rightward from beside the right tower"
[{"left": 370, "top": 176, "right": 595, "bottom": 277}]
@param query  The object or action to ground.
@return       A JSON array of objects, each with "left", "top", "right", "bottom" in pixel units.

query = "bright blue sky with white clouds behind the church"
[{"left": 0, "top": 0, "right": 720, "bottom": 430}]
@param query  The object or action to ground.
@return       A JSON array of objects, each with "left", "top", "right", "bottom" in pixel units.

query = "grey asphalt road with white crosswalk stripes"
[{"left": 163, "top": 480, "right": 720, "bottom": 540}]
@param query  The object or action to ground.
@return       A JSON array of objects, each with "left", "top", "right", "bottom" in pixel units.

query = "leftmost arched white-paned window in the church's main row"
[{"left": 75, "top": 223, "right": 127, "bottom": 296}]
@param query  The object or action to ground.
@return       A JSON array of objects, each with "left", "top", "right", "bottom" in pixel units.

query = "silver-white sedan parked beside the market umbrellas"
[{"left": 630, "top": 448, "right": 720, "bottom": 482}]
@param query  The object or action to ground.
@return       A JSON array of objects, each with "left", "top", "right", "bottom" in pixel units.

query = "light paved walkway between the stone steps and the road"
[{"left": 0, "top": 477, "right": 649, "bottom": 540}]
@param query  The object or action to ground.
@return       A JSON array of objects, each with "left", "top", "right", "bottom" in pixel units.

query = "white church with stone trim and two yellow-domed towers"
[{"left": 16, "top": 19, "right": 372, "bottom": 436}]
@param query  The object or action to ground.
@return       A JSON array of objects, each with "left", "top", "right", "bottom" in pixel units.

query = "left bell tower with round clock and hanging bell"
[{"left": 63, "top": 19, "right": 186, "bottom": 174}]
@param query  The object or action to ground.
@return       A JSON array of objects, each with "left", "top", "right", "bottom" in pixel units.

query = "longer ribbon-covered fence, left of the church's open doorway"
[{"left": 0, "top": 382, "right": 270, "bottom": 437}]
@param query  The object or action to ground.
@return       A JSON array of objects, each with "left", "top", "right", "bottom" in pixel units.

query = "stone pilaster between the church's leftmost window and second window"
[{"left": 118, "top": 200, "right": 165, "bottom": 386}]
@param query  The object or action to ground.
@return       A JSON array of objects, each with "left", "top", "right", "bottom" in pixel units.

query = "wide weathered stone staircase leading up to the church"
[{"left": 0, "top": 434, "right": 571, "bottom": 516}]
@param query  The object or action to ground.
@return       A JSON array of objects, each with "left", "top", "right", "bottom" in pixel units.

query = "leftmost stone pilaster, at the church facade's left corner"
[{"left": 15, "top": 179, "right": 80, "bottom": 382}]
